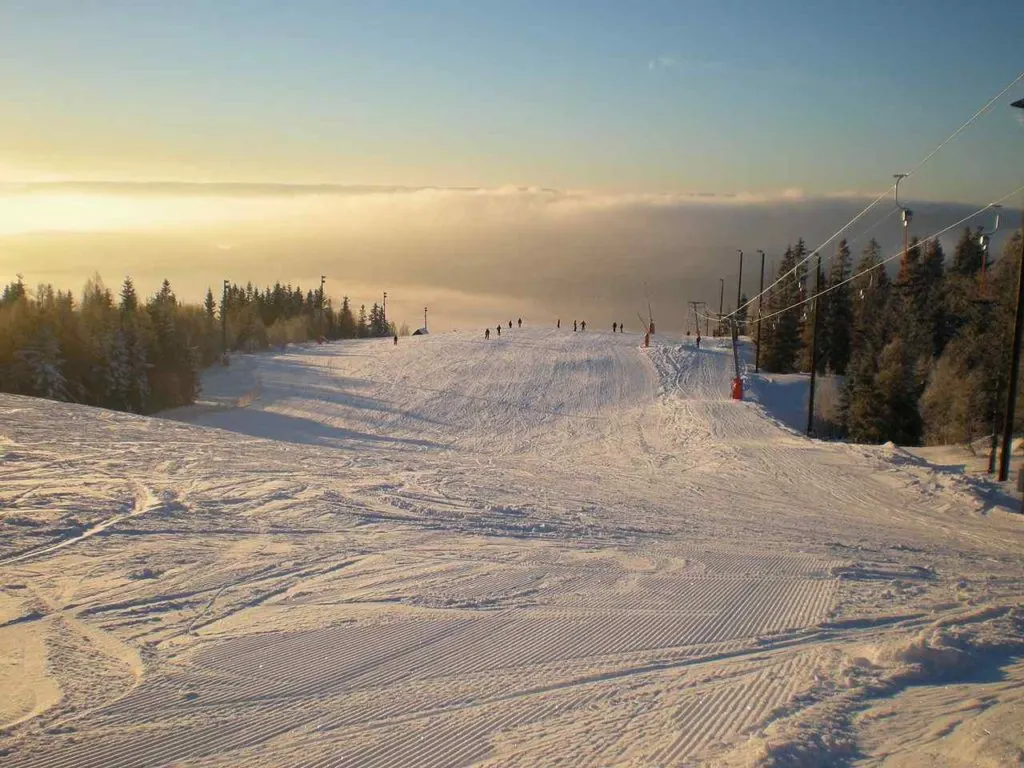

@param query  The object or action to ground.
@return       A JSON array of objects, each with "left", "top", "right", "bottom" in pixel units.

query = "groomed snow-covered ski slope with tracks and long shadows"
[{"left": 0, "top": 329, "right": 1024, "bottom": 768}]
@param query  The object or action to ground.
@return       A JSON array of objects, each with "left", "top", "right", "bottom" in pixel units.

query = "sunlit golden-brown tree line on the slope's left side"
[{"left": 0, "top": 275, "right": 396, "bottom": 414}]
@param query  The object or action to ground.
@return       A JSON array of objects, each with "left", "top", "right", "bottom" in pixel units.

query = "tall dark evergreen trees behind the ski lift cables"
[{"left": 751, "top": 227, "right": 1024, "bottom": 445}]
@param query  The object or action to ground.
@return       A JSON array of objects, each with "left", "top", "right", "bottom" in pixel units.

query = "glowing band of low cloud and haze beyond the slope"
[{"left": 0, "top": 183, "right": 1020, "bottom": 332}]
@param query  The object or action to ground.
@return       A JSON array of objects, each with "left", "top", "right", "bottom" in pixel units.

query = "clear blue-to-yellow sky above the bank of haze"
[{"left": 0, "top": 0, "right": 1024, "bottom": 202}]
